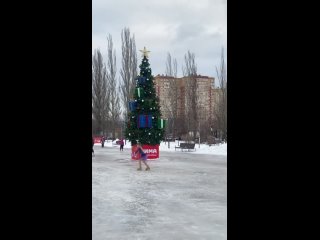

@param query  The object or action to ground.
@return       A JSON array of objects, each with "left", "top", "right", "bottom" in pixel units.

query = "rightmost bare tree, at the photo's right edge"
[{"left": 213, "top": 48, "right": 227, "bottom": 141}]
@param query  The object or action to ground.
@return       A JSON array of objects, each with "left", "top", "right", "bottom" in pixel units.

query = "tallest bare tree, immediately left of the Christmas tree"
[{"left": 120, "top": 28, "right": 137, "bottom": 119}]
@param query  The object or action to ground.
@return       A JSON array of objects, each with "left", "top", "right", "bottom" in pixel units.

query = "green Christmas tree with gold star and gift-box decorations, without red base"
[{"left": 125, "top": 47, "right": 166, "bottom": 145}]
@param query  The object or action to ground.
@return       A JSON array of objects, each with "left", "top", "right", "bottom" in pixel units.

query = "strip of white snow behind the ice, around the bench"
[{"left": 95, "top": 139, "right": 227, "bottom": 156}]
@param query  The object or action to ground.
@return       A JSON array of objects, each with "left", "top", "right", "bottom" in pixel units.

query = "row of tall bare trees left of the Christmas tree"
[{"left": 92, "top": 28, "right": 137, "bottom": 137}]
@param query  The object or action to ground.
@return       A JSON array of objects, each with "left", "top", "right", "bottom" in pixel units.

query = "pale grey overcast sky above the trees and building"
[{"left": 92, "top": 0, "right": 227, "bottom": 77}]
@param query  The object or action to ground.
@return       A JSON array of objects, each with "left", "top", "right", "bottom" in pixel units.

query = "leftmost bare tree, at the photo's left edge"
[{"left": 92, "top": 49, "right": 109, "bottom": 134}]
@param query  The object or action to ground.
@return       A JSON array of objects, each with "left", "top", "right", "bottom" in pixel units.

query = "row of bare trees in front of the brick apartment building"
[{"left": 163, "top": 49, "right": 227, "bottom": 141}]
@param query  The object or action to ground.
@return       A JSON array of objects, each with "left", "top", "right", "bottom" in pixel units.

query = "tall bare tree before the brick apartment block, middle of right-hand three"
[{"left": 182, "top": 51, "right": 199, "bottom": 141}]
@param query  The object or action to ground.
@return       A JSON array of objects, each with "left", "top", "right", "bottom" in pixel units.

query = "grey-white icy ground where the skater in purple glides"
[{"left": 92, "top": 143, "right": 227, "bottom": 240}]
